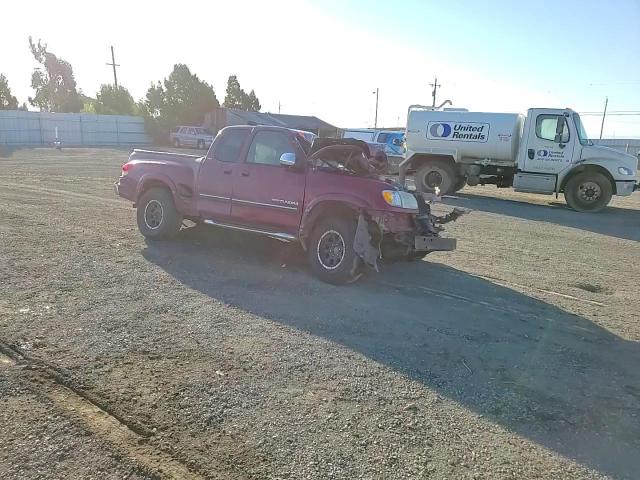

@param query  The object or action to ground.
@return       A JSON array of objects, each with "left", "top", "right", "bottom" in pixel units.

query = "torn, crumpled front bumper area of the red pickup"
[{"left": 354, "top": 193, "right": 466, "bottom": 271}]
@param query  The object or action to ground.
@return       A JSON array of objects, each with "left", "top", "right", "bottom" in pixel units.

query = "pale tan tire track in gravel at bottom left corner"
[{"left": 0, "top": 341, "right": 241, "bottom": 480}]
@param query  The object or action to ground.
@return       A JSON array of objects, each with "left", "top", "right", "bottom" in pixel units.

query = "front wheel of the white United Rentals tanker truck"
[{"left": 564, "top": 171, "right": 613, "bottom": 212}]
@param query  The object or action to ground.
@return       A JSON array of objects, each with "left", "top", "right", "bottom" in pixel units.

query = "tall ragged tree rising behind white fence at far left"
[{"left": 29, "top": 37, "right": 83, "bottom": 113}]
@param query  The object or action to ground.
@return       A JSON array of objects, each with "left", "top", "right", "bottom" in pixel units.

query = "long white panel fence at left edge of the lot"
[{"left": 0, "top": 110, "right": 151, "bottom": 147}]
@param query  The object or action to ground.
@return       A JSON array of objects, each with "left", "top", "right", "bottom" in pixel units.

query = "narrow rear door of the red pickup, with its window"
[{"left": 196, "top": 128, "right": 251, "bottom": 220}]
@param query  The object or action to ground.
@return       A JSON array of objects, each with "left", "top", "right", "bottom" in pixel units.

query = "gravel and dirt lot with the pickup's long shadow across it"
[{"left": 0, "top": 149, "right": 640, "bottom": 480}]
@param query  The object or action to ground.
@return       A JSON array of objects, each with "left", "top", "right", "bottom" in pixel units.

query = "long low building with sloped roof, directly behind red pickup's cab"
[{"left": 203, "top": 107, "right": 338, "bottom": 137}]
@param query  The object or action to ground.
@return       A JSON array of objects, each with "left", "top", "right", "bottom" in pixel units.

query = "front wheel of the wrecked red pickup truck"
[{"left": 307, "top": 217, "right": 363, "bottom": 285}]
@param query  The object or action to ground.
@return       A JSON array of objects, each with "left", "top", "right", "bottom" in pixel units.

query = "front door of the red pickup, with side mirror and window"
[{"left": 231, "top": 130, "right": 306, "bottom": 235}]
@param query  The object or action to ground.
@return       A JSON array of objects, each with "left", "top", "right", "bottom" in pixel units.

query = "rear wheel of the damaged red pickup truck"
[{"left": 137, "top": 187, "right": 182, "bottom": 240}]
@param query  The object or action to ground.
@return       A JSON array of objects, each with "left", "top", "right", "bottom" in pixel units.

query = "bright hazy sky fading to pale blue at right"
[{"left": 0, "top": 0, "right": 640, "bottom": 138}]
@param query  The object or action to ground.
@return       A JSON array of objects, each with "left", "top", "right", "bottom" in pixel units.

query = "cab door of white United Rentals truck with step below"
[{"left": 513, "top": 109, "right": 577, "bottom": 193}]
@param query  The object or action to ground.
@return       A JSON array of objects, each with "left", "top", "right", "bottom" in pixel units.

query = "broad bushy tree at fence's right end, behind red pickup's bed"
[{"left": 139, "top": 63, "right": 220, "bottom": 141}]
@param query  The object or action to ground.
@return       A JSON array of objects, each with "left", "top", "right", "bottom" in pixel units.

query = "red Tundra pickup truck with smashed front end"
[{"left": 115, "top": 126, "right": 458, "bottom": 284}]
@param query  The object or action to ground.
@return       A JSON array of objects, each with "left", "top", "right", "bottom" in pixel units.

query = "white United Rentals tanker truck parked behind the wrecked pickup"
[{"left": 399, "top": 105, "right": 640, "bottom": 212}]
